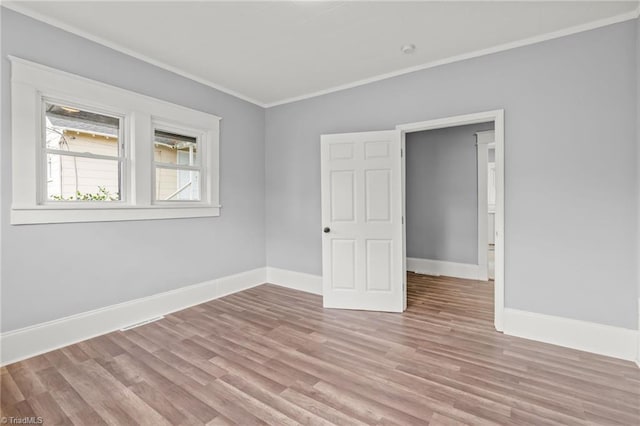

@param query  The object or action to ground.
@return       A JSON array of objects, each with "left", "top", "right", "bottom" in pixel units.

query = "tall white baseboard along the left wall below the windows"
[{"left": 0, "top": 268, "right": 266, "bottom": 365}]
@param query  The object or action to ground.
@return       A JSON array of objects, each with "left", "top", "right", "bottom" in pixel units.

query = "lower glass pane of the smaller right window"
[{"left": 156, "top": 167, "right": 200, "bottom": 201}]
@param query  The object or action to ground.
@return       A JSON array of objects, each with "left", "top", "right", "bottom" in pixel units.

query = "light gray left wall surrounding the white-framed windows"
[{"left": 1, "top": 8, "right": 265, "bottom": 331}]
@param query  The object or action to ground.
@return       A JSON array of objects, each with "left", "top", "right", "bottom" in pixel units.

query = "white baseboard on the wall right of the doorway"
[{"left": 504, "top": 308, "right": 639, "bottom": 361}]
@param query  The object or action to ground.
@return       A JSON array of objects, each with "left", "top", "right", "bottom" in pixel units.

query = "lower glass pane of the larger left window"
[{"left": 47, "top": 154, "right": 120, "bottom": 201}]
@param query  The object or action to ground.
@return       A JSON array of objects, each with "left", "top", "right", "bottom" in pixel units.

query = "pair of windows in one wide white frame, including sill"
[{"left": 10, "top": 57, "right": 220, "bottom": 224}]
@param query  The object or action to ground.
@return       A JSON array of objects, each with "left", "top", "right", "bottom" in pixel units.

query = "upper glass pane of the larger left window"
[{"left": 45, "top": 102, "right": 120, "bottom": 157}]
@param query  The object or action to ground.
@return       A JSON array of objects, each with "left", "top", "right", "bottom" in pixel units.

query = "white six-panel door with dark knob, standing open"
[{"left": 318, "top": 130, "right": 404, "bottom": 312}]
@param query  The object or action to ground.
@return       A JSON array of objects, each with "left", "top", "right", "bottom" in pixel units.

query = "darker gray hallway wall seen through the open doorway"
[{"left": 405, "top": 123, "right": 493, "bottom": 264}]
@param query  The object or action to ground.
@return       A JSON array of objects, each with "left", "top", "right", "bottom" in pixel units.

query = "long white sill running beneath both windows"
[{"left": 11, "top": 206, "right": 220, "bottom": 225}]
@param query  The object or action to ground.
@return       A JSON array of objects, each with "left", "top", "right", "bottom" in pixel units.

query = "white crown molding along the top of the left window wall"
[{"left": 2, "top": 1, "right": 265, "bottom": 108}]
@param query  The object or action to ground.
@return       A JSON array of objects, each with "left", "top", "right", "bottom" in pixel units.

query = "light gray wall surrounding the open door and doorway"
[{"left": 266, "top": 21, "right": 638, "bottom": 329}]
